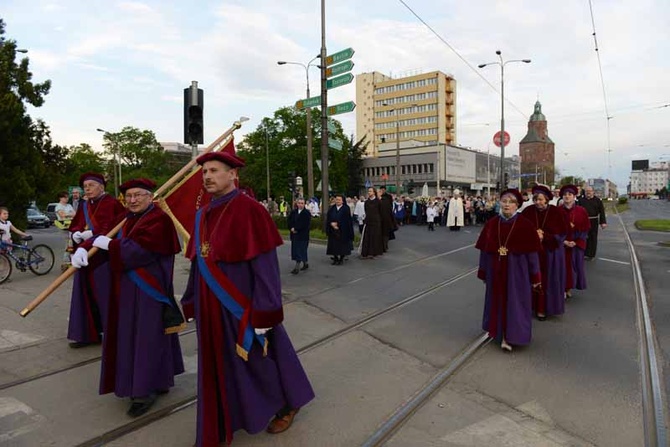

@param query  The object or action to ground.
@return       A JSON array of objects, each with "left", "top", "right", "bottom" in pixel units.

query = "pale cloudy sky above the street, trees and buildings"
[{"left": 5, "top": 0, "right": 670, "bottom": 192}]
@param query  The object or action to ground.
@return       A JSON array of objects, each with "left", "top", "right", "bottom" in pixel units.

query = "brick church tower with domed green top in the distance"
[{"left": 519, "top": 100, "right": 555, "bottom": 189}]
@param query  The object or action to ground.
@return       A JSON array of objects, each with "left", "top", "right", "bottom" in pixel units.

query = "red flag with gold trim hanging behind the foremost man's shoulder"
[{"left": 159, "top": 138, "right": 235, "bottom": 249}]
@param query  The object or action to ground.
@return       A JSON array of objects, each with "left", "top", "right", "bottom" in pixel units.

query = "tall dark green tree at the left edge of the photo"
[{"left": 0, "top": 19, "right": 51, "bottom": 225}]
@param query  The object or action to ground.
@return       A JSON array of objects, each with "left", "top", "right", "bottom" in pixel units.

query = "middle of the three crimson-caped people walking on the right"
[{"left": 521, "top": 185, "right": 568, "bottom": 321}]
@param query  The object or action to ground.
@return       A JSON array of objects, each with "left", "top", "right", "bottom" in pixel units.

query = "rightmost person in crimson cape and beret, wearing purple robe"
[{"left": 558, "top": 185, "right": 591, "bottom": 298}]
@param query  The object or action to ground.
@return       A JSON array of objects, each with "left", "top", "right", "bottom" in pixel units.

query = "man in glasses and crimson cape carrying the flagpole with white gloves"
[{"left": 71, "top": 179, "right": 184, "bottom": 417}]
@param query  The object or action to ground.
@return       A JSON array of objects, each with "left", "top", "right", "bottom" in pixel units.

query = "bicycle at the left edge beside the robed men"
[{"left": 0, "top": 236, "right": 55, "bottom": 284}]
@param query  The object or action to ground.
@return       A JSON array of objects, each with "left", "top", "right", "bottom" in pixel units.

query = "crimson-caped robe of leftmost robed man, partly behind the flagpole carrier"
[{"left": 67, "top": 194, "right": 126, "bottom": 343}]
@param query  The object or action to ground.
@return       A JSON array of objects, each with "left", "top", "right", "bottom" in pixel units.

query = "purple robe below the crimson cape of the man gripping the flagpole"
[{"left": 100, "top": 242, "right": 184, "bottom": 397}]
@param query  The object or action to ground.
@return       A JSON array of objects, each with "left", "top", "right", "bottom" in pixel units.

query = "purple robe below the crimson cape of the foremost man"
[{"left": 182, "top": 194, "right": 314, "bottom": 447}]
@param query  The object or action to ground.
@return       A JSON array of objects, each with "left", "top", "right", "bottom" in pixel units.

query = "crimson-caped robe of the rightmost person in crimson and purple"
[{"left": 558, "top": 203, "right": 591, "bottom": 292}]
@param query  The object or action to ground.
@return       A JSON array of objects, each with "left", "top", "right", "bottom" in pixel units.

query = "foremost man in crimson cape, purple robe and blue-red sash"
[{"left": 182, "top": 152, "right": 314, "bottom": 447}]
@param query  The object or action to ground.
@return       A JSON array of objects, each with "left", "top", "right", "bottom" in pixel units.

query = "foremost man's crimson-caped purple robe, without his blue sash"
[{"left": 182, "top": 190, "right": 314, "bottom": 447}]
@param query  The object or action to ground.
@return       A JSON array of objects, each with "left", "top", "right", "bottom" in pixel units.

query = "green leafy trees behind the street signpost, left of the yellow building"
[{"left": 237, "top": 107, "right": 365, "bottom": 199}]
